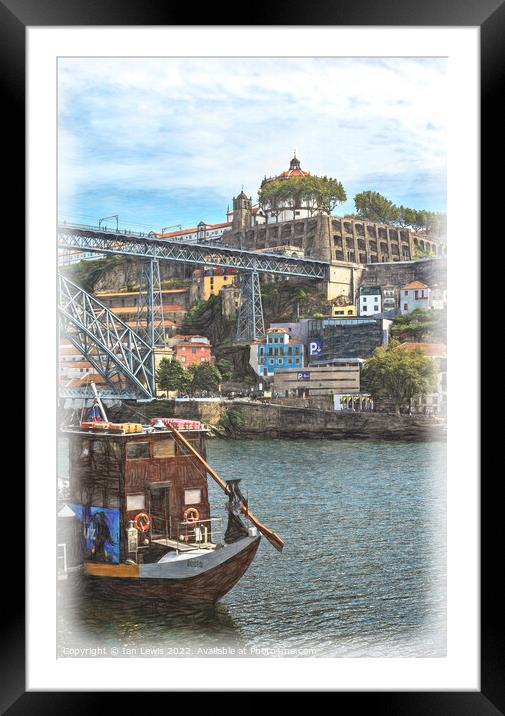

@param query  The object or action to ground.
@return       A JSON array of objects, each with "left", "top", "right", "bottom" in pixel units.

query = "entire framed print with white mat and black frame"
[{"left": 0, "top": 1, "right": 498, "bottom": 714}]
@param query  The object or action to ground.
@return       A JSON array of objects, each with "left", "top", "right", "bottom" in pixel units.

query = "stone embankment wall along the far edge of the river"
[{"left": 103, "top": 400, "right": 446, "bottom": 442}]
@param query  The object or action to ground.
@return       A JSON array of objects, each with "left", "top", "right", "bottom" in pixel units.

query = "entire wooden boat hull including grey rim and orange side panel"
[{"left": 84, "top": 536, "right": 261, "bottom": 603}]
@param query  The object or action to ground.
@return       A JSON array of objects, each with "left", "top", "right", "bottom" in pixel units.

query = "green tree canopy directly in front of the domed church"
[{"left": 258, "top": 176, "right": 347, "bottom": 214}]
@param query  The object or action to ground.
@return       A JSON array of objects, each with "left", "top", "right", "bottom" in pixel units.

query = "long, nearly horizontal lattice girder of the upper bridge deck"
[{"left": 58, "top": 224, "right": 329, "bottom": 279}]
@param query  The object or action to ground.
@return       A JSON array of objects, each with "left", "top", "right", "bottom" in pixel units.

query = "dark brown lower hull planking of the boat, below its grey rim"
[{"left": 87, "top": 537, "right": 260, "bottom": 604}]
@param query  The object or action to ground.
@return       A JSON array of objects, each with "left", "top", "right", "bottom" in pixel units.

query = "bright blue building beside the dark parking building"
[{"left": 249, "top": 328, "right": 304, "bottom": 380}]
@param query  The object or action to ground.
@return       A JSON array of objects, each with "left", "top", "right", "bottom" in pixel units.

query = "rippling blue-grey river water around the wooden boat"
[{"left": 58, "top": 440, "right": 446, "bottom": 658}]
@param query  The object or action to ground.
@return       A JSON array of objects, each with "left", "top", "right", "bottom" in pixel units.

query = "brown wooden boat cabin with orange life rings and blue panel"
[{"left": 60, "top": 422, "right": 219, "bottom": 564}]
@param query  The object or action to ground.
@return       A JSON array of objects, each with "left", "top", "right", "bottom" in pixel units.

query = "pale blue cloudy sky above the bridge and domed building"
[{"left": 58, "top": 57, "right": 447, "bottom": 231}]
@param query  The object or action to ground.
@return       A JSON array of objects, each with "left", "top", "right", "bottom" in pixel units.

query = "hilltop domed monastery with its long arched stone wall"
[{"left": 222, "top": 153, "right": 445, "bottom": 272}]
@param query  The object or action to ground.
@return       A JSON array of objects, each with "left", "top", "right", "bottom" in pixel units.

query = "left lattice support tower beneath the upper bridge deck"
[{"left": 136, "top": 259, "right": 166, "bottom": 348}]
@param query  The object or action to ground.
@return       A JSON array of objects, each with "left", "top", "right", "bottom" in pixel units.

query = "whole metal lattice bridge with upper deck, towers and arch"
[{"left": 58, "top": 223, "right": 329, "bottom": 398}]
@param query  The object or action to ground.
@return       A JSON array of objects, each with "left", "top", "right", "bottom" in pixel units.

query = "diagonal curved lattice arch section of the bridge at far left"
[{"left": 58, "top": 274, "right": 156, "bottom": 398}]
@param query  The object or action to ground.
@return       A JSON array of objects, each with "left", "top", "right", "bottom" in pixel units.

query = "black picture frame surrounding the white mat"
[{"left": 0, "top": 0, "right": 492, "bottom": 704}]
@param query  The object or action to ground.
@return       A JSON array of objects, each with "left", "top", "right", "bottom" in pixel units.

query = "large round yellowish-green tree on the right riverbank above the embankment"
[{"left": 363, "top": 339, "right": 436, "bottom": 414}]
